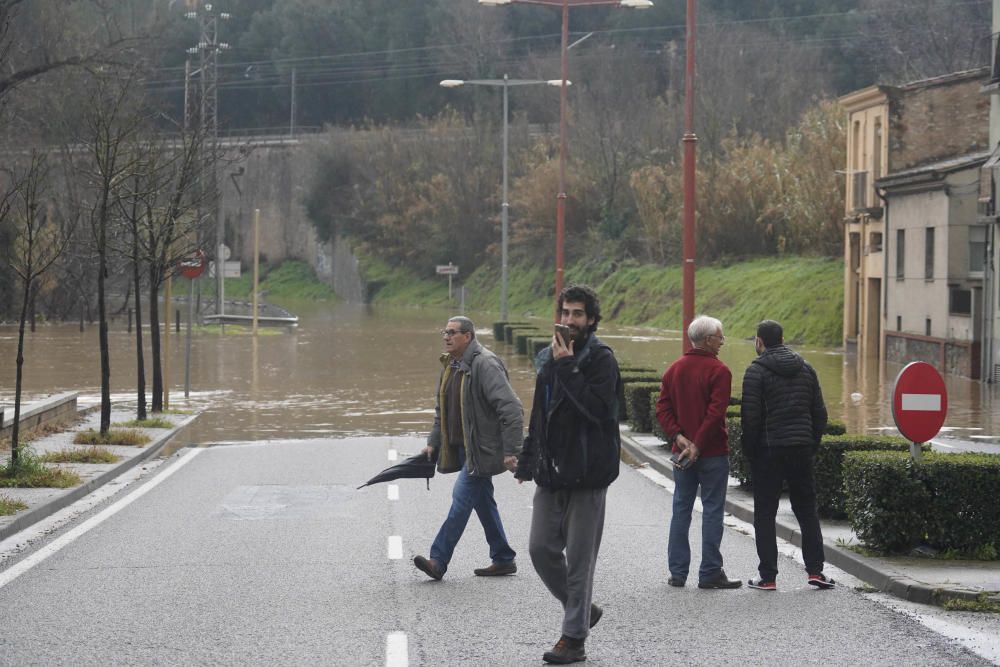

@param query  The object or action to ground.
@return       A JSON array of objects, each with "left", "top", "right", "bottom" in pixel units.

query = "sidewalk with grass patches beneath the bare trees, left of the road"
[{"left": 0, "top": 410, "right": 198, "bottom": 541}]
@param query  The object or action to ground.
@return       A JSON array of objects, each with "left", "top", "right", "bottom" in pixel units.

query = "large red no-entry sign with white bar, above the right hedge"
[{"left": 892, "top": 361, "right": 948, "bottom": 442}]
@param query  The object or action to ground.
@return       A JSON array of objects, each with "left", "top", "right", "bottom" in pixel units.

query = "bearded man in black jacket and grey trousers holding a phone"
[{"left": 516, "top": 285, "right": 621, "bottom": 664}]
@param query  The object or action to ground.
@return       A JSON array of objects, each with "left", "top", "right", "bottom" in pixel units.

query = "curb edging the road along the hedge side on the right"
[{"left": 622, "top": 435, "right": 981, "bottom": 605}]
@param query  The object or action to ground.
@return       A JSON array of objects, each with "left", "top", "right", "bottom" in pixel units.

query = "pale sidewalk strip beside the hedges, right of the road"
[{"left": 622, "top": 425, "right": 1000, "bottom": 604}]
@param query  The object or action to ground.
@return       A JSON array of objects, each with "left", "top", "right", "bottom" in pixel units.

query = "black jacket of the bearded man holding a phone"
[{"left": 516, "top": 334, "right": 621, "bottom": 489}]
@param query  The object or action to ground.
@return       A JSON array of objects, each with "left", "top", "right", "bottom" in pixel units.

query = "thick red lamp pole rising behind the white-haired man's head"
[{"left": 681, "top": 0, "right": 698, "bottom": 352}]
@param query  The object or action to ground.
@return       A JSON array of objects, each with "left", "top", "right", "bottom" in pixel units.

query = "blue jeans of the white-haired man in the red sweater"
[{"left": 667, "top": 455, "right": 729, "bottom": 581}]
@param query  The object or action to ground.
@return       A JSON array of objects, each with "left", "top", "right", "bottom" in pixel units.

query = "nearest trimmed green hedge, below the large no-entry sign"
[{"left": 844, "top": 452, "right": 1000, "bottom": 559}]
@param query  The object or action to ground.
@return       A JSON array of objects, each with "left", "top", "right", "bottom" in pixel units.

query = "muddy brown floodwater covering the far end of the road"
[{"left": 0, "top": 304, "right": 1000, "bottom": 451}]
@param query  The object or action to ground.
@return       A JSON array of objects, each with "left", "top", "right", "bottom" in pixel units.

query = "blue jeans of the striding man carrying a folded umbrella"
[{"left": 431, "top": 449, "right": 517, "bottom": 572}]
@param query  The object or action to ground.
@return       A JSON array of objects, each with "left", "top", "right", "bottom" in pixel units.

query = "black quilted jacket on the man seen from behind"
[{"left": 740, "top": 345, "right": 827, "bottom": 458}]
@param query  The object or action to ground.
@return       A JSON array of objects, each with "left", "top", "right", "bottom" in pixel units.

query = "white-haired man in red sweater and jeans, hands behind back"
[{"left": 656, "top": 315, "right": 743, "bottom": 588}]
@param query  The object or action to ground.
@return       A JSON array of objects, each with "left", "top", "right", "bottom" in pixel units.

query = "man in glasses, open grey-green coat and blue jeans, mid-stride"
[{"left": 413, "top": 316, "right": 524, "bottom": 580}]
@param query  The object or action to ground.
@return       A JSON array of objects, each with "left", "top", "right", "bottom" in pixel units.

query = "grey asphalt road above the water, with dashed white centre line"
[{"left": 0, "top": 438, "right": 989, "bottom": 667}]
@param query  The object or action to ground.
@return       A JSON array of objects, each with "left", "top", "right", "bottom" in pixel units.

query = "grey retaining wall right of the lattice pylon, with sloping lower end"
[{"left": 219, "top": 136, "right": 366, "bottom": 302}]
